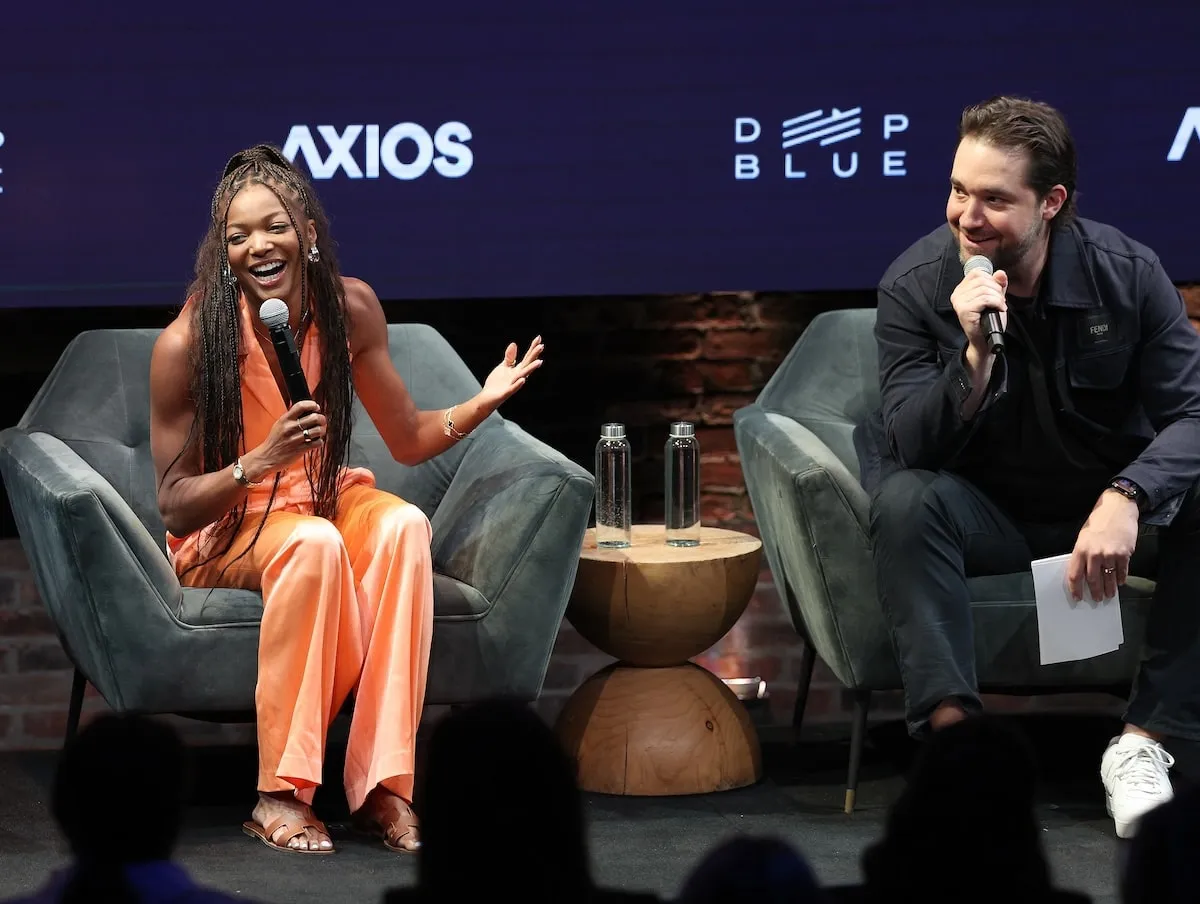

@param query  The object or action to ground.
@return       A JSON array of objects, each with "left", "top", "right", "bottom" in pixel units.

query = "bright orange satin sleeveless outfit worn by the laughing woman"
[{"left": 167, "top": 299, "right": 433, "bottom": 810}]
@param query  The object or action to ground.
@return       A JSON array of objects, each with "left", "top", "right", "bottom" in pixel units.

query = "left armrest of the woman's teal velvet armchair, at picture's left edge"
[{"left": 0, "top": 427, "right": 182, "bottom": 708}]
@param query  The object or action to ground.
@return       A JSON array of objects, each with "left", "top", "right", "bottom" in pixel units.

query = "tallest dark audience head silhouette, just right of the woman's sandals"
[{"left": 419, "top": 700, "right": 590, "bottom": 902}]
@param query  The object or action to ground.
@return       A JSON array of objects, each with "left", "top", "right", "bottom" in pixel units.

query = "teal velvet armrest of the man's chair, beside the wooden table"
[{"left": 733, "top": 405, "right": 890, "bottom": 688}]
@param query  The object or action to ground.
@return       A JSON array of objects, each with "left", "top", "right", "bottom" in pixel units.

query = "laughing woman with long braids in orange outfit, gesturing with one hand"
[{"left": 150, "top": 145, "right": 542, "bottom": 854}]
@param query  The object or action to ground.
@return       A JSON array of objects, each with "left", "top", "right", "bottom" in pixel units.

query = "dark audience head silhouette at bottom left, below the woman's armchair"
[{"left": 52, "top": 714, "right": 186, "bottom": 863}]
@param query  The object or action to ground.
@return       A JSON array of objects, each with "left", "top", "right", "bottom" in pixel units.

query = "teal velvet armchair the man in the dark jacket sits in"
[{"left": 734, "top": 309, "right": 1154, "bottom": 813}]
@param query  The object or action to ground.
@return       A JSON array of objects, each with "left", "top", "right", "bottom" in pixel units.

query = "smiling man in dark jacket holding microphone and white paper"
[{"left": 863, "top": 97, "right": 1200, "bottom": 837}]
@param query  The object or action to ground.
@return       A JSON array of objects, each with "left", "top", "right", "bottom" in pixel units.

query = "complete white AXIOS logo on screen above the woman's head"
[{"left": 283, "top": 122, "right": 475, "bottom": 179}]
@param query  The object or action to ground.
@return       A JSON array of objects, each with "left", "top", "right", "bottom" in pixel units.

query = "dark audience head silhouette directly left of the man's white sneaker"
[{"left": 863, "top": 716, "right": 1050, "bottom": 897}]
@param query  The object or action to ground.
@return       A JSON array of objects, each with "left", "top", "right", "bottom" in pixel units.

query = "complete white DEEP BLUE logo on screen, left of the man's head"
[{"left": 733, "top": 107, "right": 908, "bottom": 179}]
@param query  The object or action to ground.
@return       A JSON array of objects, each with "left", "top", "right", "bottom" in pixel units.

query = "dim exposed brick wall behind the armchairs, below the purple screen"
[{"left": 0, "top": 287, "right": 1200, "bottom": 749}]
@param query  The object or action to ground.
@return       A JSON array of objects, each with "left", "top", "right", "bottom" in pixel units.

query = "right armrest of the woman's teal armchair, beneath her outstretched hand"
[{"left": 431, "top": 420, "right": 594, "bottom": 700}]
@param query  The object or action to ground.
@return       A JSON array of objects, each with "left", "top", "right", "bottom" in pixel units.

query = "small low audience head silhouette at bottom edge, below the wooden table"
[{"left": 679, "top": 837, "right": 824, "bottom": 904}]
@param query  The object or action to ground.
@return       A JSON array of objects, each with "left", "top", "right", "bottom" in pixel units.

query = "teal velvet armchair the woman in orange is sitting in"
[{"left": 0, "top": 325, "right": 593, "bottom": 736}]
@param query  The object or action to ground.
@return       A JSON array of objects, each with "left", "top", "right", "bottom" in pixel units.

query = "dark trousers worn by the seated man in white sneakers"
[{"left": 871, "top": 471, "right": 1200, "bottom": 741}]
